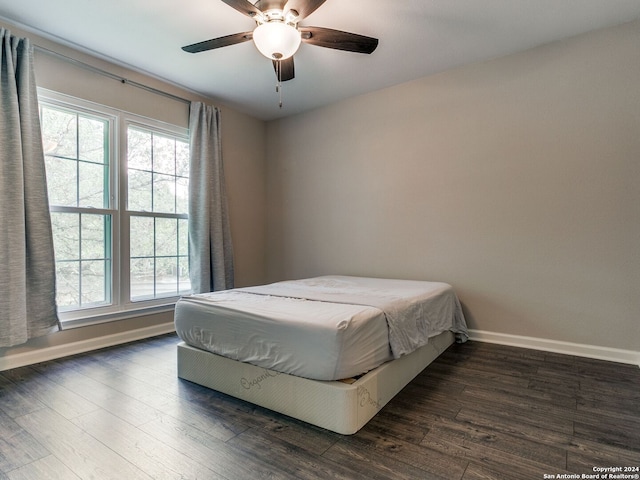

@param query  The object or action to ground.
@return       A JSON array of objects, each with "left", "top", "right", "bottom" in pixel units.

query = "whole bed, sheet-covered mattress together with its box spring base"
[{"left": 175, "top": 275, "right": 468, "bottom": 435}]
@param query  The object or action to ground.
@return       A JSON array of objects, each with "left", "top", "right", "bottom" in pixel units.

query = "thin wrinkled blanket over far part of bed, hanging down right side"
[{"left": 237, "top": 275, "right": 468, "bottom": 358}]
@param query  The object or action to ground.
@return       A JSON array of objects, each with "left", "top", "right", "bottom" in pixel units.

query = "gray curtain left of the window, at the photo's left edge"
[{"left": 0, "top": 28, "right": 60, "bottom": 347}]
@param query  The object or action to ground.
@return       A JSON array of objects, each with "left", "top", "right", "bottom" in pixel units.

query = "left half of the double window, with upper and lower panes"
[{"left": 41, "top": 105, "right": 115, "bottom": 311}]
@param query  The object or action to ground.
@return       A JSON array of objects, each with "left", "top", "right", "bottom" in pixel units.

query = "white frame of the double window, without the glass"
[{"left": 38, "top": 87, "right": 189, "bottom": 329}]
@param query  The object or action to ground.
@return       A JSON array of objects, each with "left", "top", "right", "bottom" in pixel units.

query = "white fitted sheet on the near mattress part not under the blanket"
[{"left": 175, "top": 290, "right": 393, "bottom": 380}]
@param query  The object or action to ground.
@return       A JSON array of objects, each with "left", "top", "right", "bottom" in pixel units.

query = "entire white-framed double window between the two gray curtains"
[{"left": 40, "top": 90, "right": 191, "bottom": 321}]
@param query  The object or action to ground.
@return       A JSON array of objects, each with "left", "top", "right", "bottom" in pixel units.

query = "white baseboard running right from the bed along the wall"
[{"left": 469, "top": 330, "right": 640, "bottom": 367}]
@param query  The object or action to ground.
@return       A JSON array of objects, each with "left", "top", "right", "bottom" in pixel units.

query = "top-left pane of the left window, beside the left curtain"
[{"left": 41, "top": 107, "right": 78, "bottom": 159}]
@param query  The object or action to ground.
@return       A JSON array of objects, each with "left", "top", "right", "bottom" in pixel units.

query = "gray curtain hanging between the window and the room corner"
[{"left": 189, "top": 102, "right": 233, "bottom": 293}]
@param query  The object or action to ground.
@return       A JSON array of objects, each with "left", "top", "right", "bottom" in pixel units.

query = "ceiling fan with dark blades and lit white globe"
[{"left": 182, "top": 0, "right": 378, "bottom": 82}]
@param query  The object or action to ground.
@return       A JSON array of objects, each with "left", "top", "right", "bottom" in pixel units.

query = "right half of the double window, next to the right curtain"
[{"left": 127, "top": 126, "right": 191, "bottom": 300}]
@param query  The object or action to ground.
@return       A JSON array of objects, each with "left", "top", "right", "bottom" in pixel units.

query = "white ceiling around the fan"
[{"left": 0, "top": 0, "right": 640, "bottom": 120}]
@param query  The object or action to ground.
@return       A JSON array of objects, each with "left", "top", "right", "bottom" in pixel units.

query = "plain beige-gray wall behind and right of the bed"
[{"left": 267, "top": 22, "right": 640, "bottom": 351}]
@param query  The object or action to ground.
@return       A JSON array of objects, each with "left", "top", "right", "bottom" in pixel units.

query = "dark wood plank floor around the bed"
[{"left": 0, "top": 335, "right": 640, "bottom": 480}]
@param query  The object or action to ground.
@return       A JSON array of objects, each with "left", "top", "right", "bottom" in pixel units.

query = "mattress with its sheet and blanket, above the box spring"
[{"left": 175, "top": 276, "right": 466, "bottom": 381}]
